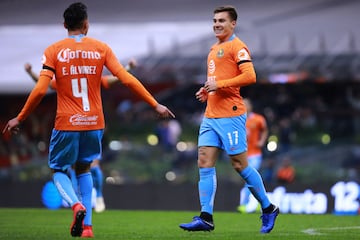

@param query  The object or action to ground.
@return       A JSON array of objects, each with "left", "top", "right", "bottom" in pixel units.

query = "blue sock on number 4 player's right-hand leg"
[{"left": 77, "top": 172, "right": 93, "bottom": 226}]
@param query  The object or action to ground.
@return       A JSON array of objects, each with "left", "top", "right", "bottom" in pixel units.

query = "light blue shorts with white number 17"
[{"left": 198, "top": 114, "right": 247, "bottom": 155}]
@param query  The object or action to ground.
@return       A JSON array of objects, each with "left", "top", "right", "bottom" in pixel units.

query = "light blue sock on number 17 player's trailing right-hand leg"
[{"left": 239, "top": 166, "right": 270, "bottom": 209}]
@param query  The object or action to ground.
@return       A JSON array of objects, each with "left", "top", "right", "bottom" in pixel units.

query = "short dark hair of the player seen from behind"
[{"left": 63, "top": 2, "right": 87, "bottom": 30}]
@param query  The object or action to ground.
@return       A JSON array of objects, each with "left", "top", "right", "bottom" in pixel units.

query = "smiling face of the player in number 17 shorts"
[{"left": 213, "top": 12, "right": 236, "bottom": 42}]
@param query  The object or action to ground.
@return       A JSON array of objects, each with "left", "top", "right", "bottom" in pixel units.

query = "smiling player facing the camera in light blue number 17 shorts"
[{"left": 180, "top": 6, "right": 279, "bottom": 233}]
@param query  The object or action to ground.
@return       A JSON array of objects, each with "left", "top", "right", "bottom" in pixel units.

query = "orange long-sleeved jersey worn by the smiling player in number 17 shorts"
[{"left": 205, "top": 35, "right": 256, "bottom": 118}]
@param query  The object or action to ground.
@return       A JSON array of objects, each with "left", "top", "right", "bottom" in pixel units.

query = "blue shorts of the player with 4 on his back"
[{"left": 49, "top": 129, "right": 104, "bottom": 171}]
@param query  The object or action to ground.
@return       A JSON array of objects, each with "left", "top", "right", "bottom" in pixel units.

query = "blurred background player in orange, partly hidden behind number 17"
[{"left": 238, "top": 99, "right": 269, "bottom": 213}]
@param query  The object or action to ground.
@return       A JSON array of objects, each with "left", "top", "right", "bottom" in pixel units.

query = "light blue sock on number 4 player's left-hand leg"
[{"left": 53, "top": 172, "right": 79, "bottom": 207}]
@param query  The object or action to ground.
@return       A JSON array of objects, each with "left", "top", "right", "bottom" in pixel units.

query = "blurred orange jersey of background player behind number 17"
[{"left": 246, "top": 112, "right": 267, "bottom": 156}]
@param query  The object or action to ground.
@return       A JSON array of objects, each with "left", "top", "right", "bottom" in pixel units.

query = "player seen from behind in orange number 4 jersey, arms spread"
[{"left": 3, "top": 2, "right": 175, "bottom": 237}]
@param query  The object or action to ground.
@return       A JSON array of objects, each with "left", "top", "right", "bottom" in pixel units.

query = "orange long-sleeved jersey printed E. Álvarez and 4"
[{"left": 17, "top": 35, "right": 157, "bottom": 131}]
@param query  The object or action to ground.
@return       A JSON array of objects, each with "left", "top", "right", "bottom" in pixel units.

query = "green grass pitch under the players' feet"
[{"left": 0, "top": 208, "right": 360, "bottom": 240}]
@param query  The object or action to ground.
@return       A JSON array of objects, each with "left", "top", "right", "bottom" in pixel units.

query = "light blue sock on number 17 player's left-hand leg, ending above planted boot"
[{"left": 198, "top": 167, "right": 217, "bottom": 214}]
